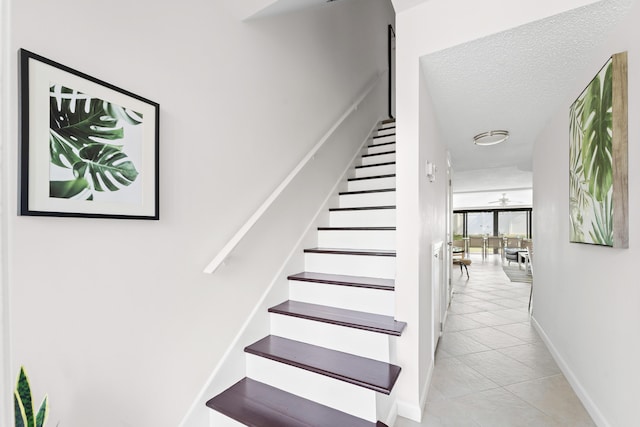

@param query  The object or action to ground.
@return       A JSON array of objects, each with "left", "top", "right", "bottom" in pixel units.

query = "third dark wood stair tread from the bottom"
[{"left": 269, "top": 300, "right": 407, "bottom": 336}]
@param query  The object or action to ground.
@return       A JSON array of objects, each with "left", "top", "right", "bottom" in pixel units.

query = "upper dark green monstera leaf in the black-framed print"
[{"left": 49, "top": 85, "right": 123, "bottom": 150}]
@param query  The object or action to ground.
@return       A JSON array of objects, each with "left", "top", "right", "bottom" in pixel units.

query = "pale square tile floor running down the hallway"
[{"left": 395, "top": 255, "right": 595, "bottom": 427}]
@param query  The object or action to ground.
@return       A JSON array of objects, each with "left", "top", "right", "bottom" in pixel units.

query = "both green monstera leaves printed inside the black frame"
[{"left": 49, "top": 85, "right": 143, "bottom": 200}]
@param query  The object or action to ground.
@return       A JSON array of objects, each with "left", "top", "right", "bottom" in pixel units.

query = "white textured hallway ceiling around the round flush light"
[{"left": 421, "top": 0, "right": 631, "bottom": 191}]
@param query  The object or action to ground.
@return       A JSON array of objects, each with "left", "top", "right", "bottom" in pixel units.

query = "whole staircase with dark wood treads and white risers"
[{"left": 207, "top": 120, "right": 406, "bottom": 427}]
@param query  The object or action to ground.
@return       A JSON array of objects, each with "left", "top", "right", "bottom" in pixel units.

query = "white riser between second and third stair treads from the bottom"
[{"left": 271, "top": 313, "right": 389, "bottom": 363}]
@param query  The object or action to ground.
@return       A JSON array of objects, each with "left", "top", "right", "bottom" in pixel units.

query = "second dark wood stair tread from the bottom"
[{"left": 245, "top": 335, "right": 400, "bottom": 394}]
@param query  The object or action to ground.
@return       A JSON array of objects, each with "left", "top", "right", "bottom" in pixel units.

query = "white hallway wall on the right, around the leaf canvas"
[{"left": 533, "top": 4, "right": 640, "bottom": 426}]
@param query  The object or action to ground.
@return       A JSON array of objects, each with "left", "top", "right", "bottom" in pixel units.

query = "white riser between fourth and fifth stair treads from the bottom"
[{"left": 304, "top": 253, "right": 396, "bottom": 279}]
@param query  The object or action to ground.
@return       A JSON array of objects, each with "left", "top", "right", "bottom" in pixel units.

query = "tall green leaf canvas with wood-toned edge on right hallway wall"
[{"left": 569, "top": 52, "right": 629, "bottom": 248}]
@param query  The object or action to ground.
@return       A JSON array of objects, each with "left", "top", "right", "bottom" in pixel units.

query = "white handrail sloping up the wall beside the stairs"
[{"left": 204, "top": 72, "right": 383, "bottom": 274}]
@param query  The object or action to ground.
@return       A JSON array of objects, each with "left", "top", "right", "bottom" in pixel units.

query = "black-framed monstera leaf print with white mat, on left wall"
[{"left": 18, "top": 49, "right": 160, "bottom": 220}]
